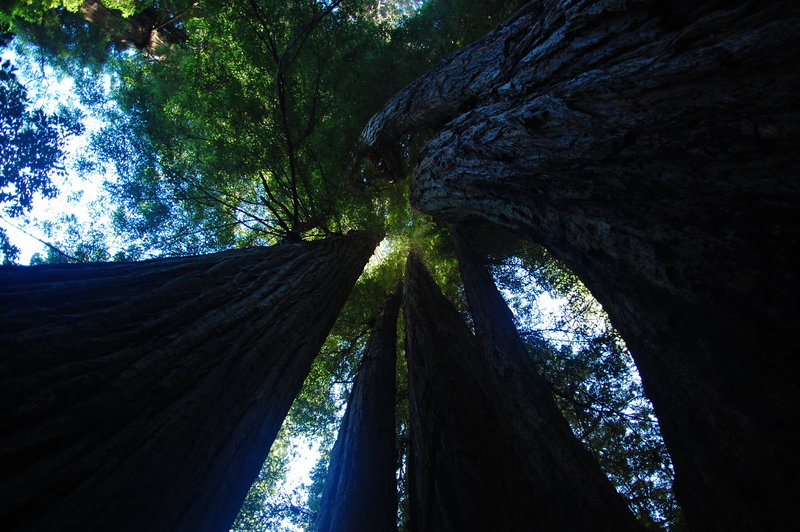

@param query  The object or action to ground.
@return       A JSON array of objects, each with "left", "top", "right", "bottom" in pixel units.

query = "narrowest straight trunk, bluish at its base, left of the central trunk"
[{"left": 315, "top": 283, "right": 401, "bottom": 532}]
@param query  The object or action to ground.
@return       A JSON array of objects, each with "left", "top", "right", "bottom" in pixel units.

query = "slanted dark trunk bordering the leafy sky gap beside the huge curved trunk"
[{"left": 451, "top": 222, "right": 636, "bottom": 530}]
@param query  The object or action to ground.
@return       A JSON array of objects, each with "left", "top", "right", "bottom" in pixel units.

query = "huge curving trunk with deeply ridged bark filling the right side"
[{"left": 361, "top": 0, "right": 800, "bottom": 530}]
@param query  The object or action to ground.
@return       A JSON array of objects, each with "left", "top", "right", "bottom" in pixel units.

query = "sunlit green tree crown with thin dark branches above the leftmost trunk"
[{"left": 82, "top": 1, "right": 410, "bottom": 246}]
